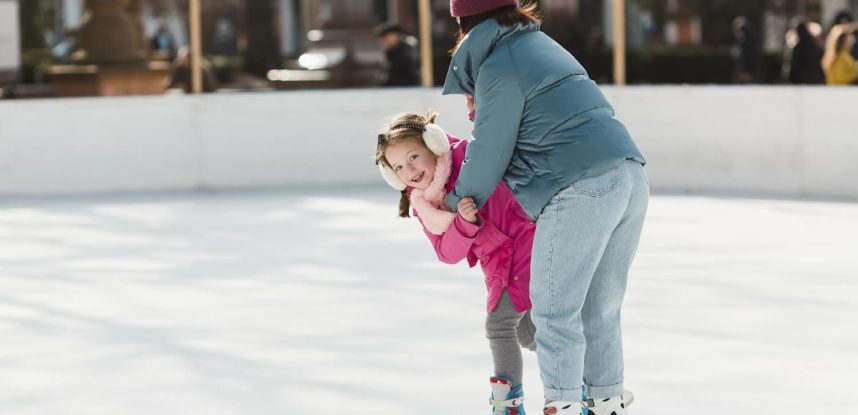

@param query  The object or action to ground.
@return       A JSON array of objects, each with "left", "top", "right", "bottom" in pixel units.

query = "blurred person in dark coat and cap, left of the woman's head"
[{"left": 376, "top": 23, "right": 420, "bottom": 86}]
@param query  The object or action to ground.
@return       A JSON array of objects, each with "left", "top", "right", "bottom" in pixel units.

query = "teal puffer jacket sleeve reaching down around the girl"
[{"left": 447, "top": 48, "right": 525, "bottom": 211}]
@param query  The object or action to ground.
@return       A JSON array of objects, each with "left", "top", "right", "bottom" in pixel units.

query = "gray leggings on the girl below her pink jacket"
[{"left": 486, "top": 290, "right": 536, "bottom": 386}]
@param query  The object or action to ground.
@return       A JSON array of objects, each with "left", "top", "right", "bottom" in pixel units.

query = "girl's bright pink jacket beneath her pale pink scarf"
[{"left": 413, "top": 135, "right": 536, "bottom": 312}]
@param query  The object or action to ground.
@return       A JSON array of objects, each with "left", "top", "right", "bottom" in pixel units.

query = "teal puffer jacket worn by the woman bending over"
[{"left": 444, "top": 19, "right": 645, "bottom": 221}]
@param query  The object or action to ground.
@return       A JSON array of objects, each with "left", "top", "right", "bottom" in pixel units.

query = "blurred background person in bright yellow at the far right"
[{"left": 822, "top": 23, "right": 858, "bottom": 85}]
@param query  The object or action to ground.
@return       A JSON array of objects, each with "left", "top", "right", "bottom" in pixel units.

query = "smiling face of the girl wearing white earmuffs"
[{"left": 384, "top": 139, "right": 437, "bottom": 190}]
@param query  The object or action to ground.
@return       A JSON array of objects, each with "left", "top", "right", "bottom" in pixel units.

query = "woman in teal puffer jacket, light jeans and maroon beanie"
[{"left": 444, "top": 0, "right": 649, "bottom": 415}]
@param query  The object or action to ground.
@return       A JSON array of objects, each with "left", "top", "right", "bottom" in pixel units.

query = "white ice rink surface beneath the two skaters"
[{"left": 0, "top": 187, "right": 858, "bottom": 415}]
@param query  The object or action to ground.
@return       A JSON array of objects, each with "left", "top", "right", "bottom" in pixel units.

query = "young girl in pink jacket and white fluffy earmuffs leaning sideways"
[{"left": 376, "top": 113, "right": 536, "bottom": 415}]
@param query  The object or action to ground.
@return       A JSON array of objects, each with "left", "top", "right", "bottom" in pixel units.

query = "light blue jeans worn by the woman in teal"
[{"left": 530, "top": 160, "right": 649, "bottom": 402}]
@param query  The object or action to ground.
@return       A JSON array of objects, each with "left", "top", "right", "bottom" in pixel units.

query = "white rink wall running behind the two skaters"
[{"left": 0, "top": 86, "right": 858, "bottom": 198}]
